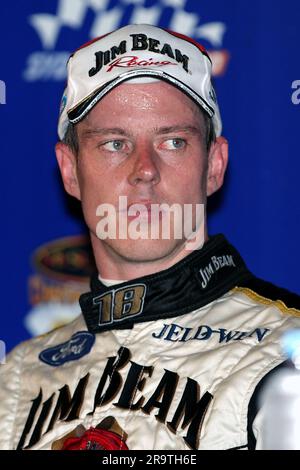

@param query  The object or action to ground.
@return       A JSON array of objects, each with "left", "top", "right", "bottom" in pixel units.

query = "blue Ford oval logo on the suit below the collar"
[{"left": 39, "top": 331, "right": 95, "bottom": 367}]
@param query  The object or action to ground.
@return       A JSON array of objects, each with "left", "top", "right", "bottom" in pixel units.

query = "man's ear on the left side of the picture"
[{"left": 55, "top": 142, "right": 81, "bottom": 200}]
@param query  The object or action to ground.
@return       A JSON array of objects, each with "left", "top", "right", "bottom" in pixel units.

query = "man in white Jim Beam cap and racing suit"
[{"left": 0, "top": 25, "right": 300, "bottom": 450}]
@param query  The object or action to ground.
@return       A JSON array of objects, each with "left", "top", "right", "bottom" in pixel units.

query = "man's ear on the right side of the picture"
[{"left": 206, "top": 137, "right": 228, "bottom": 196}]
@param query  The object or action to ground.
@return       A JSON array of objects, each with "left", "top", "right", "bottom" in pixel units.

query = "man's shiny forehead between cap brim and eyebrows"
[{"left": 79, "top": 80, "right": 203, "bottom": 127}]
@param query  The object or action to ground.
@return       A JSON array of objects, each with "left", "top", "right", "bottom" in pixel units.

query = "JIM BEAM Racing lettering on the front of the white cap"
[{"left": 89, "top": 34, "right": 190, "bottom": 77}]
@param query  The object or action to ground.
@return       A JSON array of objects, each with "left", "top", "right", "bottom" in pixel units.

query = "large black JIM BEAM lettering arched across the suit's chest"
[{"left": 17, "top": 347, "right": 213, "bottom": 450}]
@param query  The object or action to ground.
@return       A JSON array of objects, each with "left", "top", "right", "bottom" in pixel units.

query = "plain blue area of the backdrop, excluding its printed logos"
[{"left": 0, "top": 0, "right": 300, "bottom": 349}]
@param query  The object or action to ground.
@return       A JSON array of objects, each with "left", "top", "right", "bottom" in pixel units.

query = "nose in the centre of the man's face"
[{"left": 128, "top": 145, "right": 160, "bottom": 186}]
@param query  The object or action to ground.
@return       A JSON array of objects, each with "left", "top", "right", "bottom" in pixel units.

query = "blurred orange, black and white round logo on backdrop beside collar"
[{"left": 24, "top": 235, "right": 96, "bottom": 336}]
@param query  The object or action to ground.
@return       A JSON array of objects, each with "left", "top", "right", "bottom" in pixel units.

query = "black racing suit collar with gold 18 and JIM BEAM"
[{"left": 79, "top": 234, "right": 252, "bottom": 333}]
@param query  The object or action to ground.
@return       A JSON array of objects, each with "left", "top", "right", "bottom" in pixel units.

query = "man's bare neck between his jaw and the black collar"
[{"left": 91, "top": 227, "right": 208, "bottom": 281}]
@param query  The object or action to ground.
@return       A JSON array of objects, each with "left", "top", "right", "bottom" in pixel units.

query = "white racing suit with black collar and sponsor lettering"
[{"left": 0, "top": 235, "right": 300, "bottom": 450}]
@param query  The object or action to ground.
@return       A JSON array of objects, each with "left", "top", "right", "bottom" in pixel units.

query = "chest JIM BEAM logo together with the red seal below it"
[{"left": 17, "top": 346, "right": 211, "bottom": 450}]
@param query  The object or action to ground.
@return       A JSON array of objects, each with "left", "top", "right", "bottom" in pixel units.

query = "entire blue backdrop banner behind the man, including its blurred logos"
[{"left": 0, "top": 0, "right": 300, "bottom": 351}]
